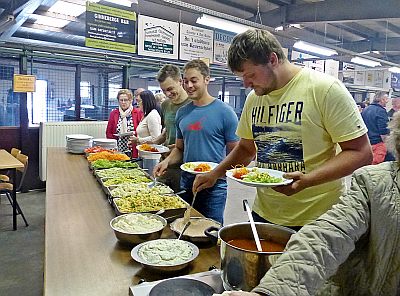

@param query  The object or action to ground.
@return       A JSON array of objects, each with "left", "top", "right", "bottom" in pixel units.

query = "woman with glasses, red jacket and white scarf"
[{"left": 106, "top": 89, "right": 143, "bottom": 157}]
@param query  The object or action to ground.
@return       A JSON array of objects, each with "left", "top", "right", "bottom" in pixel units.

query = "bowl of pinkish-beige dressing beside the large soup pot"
[{"left": 170, "top": 217, "right": 222, "bottom": 244}]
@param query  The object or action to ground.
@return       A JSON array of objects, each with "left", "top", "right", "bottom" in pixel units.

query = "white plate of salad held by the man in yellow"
[{"left": 226, "top": 167, "right": 293, "bottom": 187}]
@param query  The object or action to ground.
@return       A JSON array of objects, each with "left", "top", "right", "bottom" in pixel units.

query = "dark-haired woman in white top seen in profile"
[{"left": 130, "top": 90, "right": 162, "bottom": 172}]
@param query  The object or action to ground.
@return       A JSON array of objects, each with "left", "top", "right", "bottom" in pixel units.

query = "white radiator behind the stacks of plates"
[{"left": 39, "top": 121, "right": 107, "bottom": 181}]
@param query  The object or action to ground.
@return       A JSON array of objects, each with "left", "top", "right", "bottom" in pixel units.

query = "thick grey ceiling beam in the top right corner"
[{"left": 261, "top": 0, "right": 400, "bottom": 27}]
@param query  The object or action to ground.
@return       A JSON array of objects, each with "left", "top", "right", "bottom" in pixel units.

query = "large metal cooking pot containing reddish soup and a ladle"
[{"left": 205, "top": 222, "right": 296, "bottom": 291}]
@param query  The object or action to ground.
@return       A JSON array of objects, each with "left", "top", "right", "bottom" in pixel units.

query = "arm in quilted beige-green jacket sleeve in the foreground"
[{"left": 253, "top": 171, "right": 370, "bottom": 296}]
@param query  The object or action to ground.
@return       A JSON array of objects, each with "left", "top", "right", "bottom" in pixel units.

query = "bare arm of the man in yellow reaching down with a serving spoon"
[{"left": 193, "top": 139, "right": 256, "bottom": 192}]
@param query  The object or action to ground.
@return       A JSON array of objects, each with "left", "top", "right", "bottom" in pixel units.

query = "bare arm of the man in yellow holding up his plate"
[{"left": 274, "top": 134, "right": 372, "bottom": 195}]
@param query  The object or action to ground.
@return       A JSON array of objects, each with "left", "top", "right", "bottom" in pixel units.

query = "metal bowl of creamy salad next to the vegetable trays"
[{"left": 110, "top": 213, "right": 167, "bottom": 245}]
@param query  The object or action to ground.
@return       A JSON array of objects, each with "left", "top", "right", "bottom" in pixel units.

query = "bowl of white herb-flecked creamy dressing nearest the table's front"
[{"left": 131, "top": 239, "right": 199, "bottom": 272}]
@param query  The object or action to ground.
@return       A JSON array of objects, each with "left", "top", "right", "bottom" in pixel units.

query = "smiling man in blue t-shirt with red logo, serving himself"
[{"left": 154, "top": 60, "right": 238, "bottom": 224}]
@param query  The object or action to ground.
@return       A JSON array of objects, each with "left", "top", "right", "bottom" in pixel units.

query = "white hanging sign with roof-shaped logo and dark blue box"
[{"left": 138, "top": 15, "right": 179, "bottom": 60}]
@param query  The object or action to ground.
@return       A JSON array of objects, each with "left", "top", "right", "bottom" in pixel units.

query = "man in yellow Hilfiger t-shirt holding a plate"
[{"left": 193, "top": 29, "right": 372, "bottom": 229}]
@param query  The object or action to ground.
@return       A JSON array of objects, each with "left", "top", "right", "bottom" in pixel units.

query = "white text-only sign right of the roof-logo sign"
[{"left": 179, "top": 24, "right": 214, "bottom": 63}]
